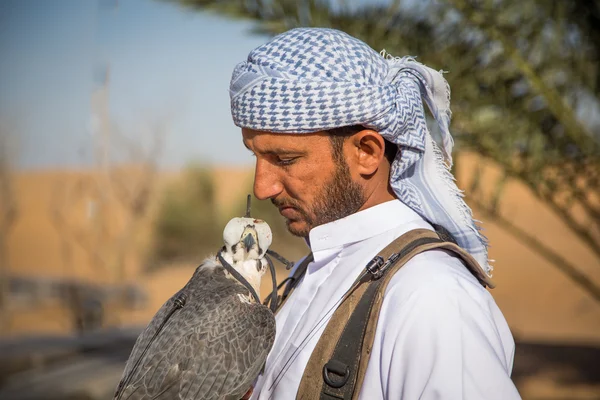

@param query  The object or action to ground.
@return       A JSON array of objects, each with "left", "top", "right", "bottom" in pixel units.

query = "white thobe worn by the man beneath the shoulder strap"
[{"left": 252, "top": 200, "right": 520, "bottom": 400}]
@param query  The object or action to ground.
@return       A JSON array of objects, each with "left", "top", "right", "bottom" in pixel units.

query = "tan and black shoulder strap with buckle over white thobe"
[{"left": 296, "top": 229, "right": 493, "bottom": 400}]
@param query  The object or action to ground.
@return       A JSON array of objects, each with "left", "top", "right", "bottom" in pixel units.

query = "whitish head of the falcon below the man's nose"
[{"left": 223, "top": 218, "right": 273, "bottom": 275}]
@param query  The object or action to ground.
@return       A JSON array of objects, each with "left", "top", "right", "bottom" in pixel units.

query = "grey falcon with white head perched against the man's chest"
[{"left": 114, "top": 212, "right": 276, "bottom": 400}]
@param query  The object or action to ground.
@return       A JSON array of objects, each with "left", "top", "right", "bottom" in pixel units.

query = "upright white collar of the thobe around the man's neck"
[{"left": 309, "top": 200, "right": 423, "bottom": 260}]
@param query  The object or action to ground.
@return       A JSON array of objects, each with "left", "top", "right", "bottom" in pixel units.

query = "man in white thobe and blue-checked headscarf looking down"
[{"left": 230, "top": 28, "right": 519, "bottom": 400}]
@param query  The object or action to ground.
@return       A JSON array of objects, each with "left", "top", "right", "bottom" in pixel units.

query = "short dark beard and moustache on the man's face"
[{"left": 271, "top": 161, "right": 365, "bottom": 237}]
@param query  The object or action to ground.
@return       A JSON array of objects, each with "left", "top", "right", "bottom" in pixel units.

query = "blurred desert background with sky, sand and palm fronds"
[{"left": 0, "top": 0, "right": 600, "bottom": 400}]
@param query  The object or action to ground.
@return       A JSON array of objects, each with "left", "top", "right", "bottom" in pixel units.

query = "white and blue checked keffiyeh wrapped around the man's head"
[{"left": 230, "top": 28, "right": 491, "bottom": 274}]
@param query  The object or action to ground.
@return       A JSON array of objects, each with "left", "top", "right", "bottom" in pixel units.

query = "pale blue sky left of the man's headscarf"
[{"left": 0, "top": 0, "right": 266, "bottom": 168}]
